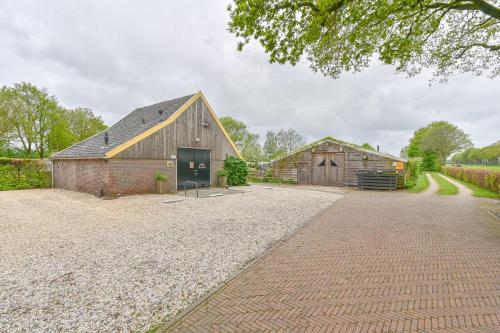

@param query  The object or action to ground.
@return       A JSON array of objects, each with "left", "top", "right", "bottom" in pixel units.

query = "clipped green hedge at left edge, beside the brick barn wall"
[{"left": 0, "top": 157, "right": 51, "bottom": 191}]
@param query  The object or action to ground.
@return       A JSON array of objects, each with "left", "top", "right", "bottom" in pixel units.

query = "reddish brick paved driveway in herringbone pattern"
[{"left": 168, "top": 192, "right": 500, "bottom": 332}]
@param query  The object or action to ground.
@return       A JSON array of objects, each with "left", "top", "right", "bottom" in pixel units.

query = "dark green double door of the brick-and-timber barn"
[{"left": 177, "top": 148, "right": 210, "bottom": 190}]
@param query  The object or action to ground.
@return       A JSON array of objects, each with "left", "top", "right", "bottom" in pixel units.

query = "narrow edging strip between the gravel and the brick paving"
[{"left": 150, "top": 194, "right": 346, "bottom": 333}]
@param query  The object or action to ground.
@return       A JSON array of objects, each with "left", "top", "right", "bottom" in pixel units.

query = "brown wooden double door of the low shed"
[{"left": 312, "top": 153, "right": 345, "bottom": 186}]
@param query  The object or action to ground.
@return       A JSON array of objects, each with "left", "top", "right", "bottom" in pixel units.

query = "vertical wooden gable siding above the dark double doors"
[{"left": 114, "top": 98, "right": 236, "bottom": 161}]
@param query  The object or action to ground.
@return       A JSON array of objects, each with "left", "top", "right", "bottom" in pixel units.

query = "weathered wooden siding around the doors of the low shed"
[{"left": 273, "top": 142, "right": 402, "bottom": 186}]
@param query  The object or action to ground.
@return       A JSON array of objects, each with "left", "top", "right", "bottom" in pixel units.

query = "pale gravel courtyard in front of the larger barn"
[{"left": 0, "top": 186, "right": 341, "bottom": 332}]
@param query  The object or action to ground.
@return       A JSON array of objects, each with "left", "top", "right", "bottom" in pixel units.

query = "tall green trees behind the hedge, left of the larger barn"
[{"left": 0, "top": 82, "right": 107, "bottom": 158}]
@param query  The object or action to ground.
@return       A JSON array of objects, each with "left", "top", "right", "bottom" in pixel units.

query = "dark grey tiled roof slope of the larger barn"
[{"left": 51, "top": 94, "right": 195, "bottom": 159}]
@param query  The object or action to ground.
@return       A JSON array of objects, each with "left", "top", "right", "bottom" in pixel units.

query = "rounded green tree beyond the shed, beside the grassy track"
[{"left": 421, "top": 121, "right": 472, "bottom": 163}]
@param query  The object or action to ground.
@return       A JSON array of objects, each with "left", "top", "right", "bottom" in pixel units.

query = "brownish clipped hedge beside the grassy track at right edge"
[{"left": 441, "top": 166, "right": 500, "bottom": 193}]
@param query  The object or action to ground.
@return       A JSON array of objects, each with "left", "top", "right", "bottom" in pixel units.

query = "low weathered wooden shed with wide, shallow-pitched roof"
[{"left": 272, "top": 137, "right": 407, "bottom": 186}]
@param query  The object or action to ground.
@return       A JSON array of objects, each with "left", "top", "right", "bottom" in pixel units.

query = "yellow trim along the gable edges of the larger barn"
[{"left": 104, "top": 91, "right": 242, "bottom": 158}]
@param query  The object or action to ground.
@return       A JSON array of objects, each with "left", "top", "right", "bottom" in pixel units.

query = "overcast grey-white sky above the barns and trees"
[{"left": 0, "top": 0, "right": 500, "bottom": 155}]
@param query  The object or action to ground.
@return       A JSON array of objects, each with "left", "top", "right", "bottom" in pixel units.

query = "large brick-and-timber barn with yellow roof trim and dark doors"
[{"left": 51, "top": 91, "right": 241, "bottom": 195}]
